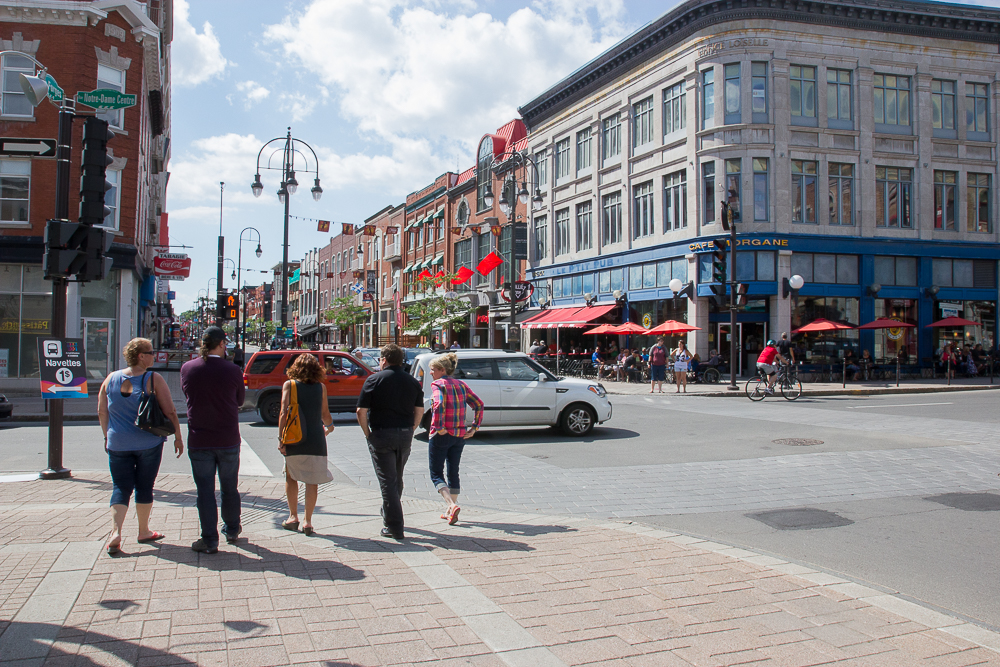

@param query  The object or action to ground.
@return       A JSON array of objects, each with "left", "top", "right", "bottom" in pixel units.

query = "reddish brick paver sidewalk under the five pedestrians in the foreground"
[{"left": 0, "top": 473, "right": 1000, "bottom": 667}]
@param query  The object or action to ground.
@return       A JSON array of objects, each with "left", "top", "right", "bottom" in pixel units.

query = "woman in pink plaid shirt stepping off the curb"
[{"left": 428, "top": 353, "right": 483, "bottom": 525}]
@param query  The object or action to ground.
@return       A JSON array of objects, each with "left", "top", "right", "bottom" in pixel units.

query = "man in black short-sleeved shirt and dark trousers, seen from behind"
[{"left": 357, "top": 343, "right": 422, "bottom": 540}]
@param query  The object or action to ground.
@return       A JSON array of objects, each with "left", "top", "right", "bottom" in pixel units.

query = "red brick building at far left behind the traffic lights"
[{"left": 0, "top": 0, "right": 172, "bottom": 389}]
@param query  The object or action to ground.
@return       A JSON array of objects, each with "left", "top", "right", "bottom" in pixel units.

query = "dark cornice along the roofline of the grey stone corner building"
[{"left": 518, "top": 0, "right": 1000, "bottom": 128}]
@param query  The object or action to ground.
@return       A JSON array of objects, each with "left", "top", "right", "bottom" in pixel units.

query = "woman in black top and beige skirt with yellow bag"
[{"left": 278, "top": 354, "right": 333, "bottom": 535}]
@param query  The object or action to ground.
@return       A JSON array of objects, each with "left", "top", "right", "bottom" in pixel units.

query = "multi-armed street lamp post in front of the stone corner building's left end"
[{"left": 483, "top": 151, "right": 542, "bottom": 350}]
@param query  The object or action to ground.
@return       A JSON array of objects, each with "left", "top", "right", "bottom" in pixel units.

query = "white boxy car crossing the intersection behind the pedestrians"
[{"left": 410, "top": 350, "right": 611, "bottom": 436}]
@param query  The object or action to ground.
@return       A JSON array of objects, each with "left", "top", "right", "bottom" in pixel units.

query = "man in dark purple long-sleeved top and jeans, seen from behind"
[{"left": 181, "top": 327, "right": 246, "bottom": 554}]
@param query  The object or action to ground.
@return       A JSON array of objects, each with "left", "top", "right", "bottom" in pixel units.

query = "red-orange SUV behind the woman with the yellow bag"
[{"left": 243, "top": 350, "right": 373, "bottom": 426}]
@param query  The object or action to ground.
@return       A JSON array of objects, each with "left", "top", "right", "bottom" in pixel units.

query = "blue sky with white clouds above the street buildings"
[{"left": 165, "top": 0, "right": 1000, "bottom": 312}]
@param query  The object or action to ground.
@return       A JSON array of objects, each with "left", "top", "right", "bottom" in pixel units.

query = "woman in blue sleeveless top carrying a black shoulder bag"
[{"left": 97, "top": 338, "right": 184, "bottom": 556}]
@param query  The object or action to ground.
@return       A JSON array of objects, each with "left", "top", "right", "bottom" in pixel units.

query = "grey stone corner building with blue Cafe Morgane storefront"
[{"left": 520, "top": 0, "right": 1000, "bottom": 369}]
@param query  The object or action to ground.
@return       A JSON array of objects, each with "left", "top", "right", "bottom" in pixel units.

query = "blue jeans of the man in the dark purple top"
[{"left": 188, "top": 447, "right": 240, "bottom": 546}]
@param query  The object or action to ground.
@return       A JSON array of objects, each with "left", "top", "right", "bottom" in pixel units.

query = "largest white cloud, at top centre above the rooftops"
[{"left": 265, "top": 0, "right": 624, "bottom": 160}]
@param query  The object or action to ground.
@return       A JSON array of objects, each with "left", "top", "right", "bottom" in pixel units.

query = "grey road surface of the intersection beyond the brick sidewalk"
[{"left": 0, "top": 391, "right": 1000, "bottom": 630}]
